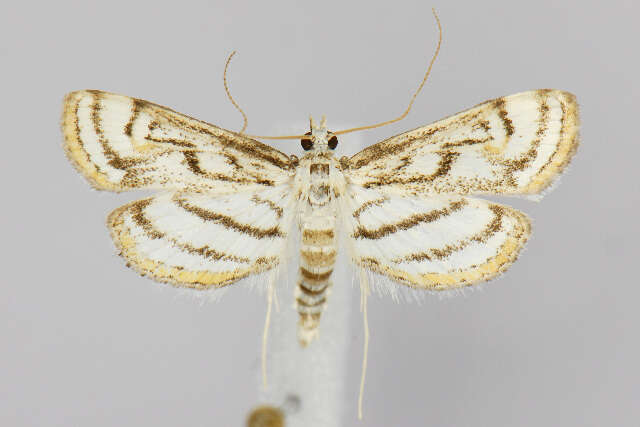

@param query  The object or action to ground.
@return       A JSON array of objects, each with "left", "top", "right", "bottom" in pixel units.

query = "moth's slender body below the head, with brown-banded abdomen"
[{"left": 295, "top": 160, "right": 337, "bottom": 346}]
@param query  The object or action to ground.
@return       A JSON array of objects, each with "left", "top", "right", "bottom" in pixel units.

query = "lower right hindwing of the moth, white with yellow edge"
[{"left": 343, "top": 186, "right": 530, "bottom": 290}]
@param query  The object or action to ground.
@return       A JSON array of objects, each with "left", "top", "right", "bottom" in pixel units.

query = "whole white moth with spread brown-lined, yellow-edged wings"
[{"left": 62, "top": 89, "right": 579, "bottom": 346}]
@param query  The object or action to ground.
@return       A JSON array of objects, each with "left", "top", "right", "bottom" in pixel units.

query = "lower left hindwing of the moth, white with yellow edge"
[{"left": 107, "top": 185, "right": 294, "bottom": 289}]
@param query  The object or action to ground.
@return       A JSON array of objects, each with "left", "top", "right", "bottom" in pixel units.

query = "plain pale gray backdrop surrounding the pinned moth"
[{"left": 0, "top": 0, "right": 640, "bottom": 426}]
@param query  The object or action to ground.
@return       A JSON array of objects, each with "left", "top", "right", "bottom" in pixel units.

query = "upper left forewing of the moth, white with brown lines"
[{"left": 62, "top": 90, "right": 296, "bottom": 194}]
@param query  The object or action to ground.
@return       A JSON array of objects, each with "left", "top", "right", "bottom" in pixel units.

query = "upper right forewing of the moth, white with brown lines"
[{"left": 341, "top": 89, "right": 579, "bottom": 195}]
